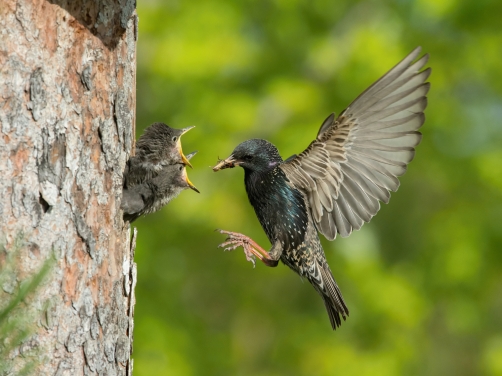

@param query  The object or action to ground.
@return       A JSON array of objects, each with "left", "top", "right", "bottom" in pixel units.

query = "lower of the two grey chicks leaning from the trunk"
[{"left": 120, "top": 152, "right": 199, "bottom": 223}]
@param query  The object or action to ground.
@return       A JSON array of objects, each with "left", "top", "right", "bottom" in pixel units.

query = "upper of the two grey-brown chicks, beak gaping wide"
[{"left": 123, "top": 123, "right": 194, "bottom": 189}]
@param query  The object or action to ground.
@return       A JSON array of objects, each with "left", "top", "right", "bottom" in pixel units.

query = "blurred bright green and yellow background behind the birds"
[{"left": 133, "top": 0, "right": 502, "bottom": 376}]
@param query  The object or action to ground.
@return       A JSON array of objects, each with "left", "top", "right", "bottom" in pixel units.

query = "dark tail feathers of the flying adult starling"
[{"left": 314, "top": 263, "right": 349, "bottom": 330}]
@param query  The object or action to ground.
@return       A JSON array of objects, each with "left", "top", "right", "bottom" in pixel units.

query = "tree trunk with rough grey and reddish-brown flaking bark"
[{"left": 0, "top": 0, "right": 137, "bottom": 376}]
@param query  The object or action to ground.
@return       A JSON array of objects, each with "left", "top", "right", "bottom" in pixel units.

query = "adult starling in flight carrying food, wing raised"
[{"left": 213, "top": 47, "right": 431, "bottom": 329}]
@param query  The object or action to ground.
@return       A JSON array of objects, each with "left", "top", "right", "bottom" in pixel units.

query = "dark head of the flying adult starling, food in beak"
[{"left": 213, "top": 138, "right": 282, "bottom": 172}]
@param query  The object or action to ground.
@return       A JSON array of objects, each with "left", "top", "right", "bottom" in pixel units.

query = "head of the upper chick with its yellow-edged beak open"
[{"left": 136, "top": 123, "right": 194, "bottom": 168}]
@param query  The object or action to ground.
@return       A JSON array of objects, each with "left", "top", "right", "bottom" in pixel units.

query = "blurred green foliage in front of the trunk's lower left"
[{"left": 0, "top": 234, "right": 55, "bottom": 376}]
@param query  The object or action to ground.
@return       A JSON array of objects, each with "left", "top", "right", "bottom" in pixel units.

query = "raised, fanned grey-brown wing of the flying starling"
[{"left": 281, "top": 47, "right": 430, "bottom": 240}]
